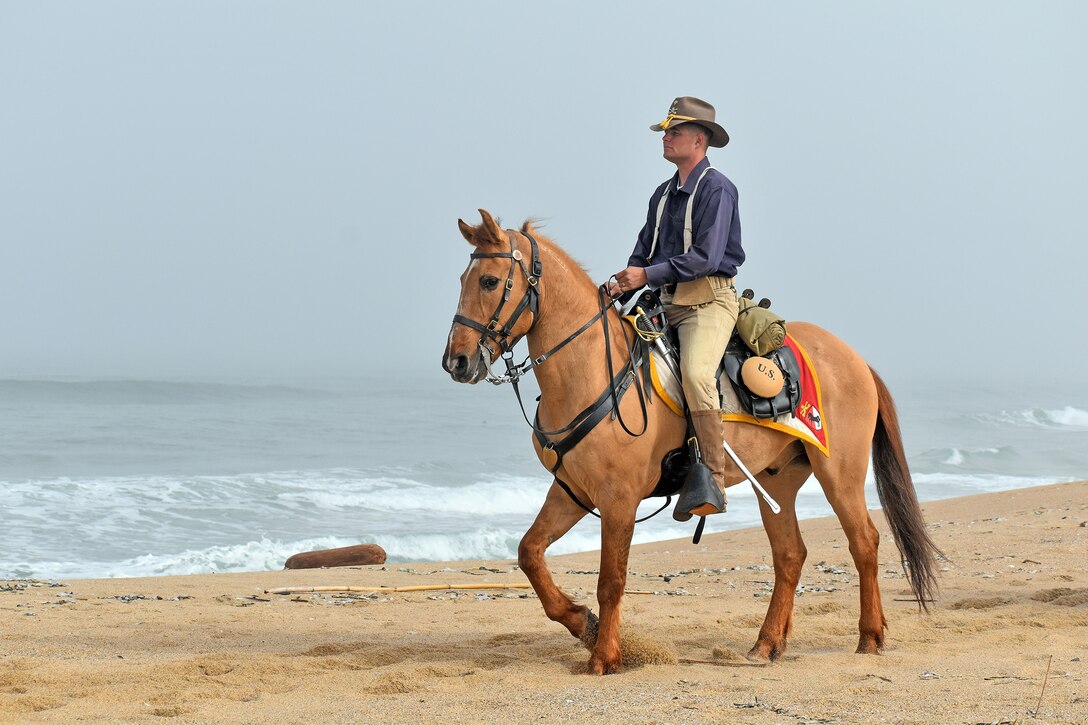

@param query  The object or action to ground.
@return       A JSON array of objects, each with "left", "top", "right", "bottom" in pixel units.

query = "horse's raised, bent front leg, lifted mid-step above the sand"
[{"left": 518, "top": 482, "right": 596, "bottom": 648}]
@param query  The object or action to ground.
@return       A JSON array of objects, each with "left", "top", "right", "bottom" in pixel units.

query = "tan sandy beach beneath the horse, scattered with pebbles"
[{"left": 0, "top": 481, "right": 1088, "bottom": 723}]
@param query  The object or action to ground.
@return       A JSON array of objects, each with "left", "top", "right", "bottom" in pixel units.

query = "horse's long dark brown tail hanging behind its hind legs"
[{"left": 869, "top": 368, "right": 943, "bottom": 611}]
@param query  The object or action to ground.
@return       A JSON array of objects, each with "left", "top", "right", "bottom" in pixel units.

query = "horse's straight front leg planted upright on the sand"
[{"left": 589, "top": 501, "right": 638, "bottom": 675}]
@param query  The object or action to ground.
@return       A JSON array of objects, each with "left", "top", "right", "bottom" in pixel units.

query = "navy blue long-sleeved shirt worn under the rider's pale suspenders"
[{"left": 628, "top": 158, "right": 744, "bottom": 287}]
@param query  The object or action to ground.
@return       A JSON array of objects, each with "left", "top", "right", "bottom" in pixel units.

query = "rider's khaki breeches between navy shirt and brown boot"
[{"left": 662, "top": 277, "right": 738, "bottom": 410}]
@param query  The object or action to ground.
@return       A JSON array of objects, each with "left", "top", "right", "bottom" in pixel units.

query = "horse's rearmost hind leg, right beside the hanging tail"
[{"left": 813, "top": 437, "right": 888, "bottom": 654}]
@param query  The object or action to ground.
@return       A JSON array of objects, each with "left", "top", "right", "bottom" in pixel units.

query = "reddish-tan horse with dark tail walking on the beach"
[{"left": 443, "top": 209, "right": 940, "bottom": 674}]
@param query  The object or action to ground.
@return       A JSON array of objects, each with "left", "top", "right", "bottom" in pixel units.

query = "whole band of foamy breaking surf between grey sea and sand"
[{"left": 0, "top": 465, "right": 1074, "bottom": 578}]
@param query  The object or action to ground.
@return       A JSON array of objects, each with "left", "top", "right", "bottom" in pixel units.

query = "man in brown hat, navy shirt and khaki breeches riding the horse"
[{"left": 611, "top": 96, "right": 744, "bottom": 520}]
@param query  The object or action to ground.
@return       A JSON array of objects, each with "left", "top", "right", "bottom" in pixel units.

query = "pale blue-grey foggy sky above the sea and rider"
[{"left": 0, "top": 0, "right": 1088, "bottom": 379}]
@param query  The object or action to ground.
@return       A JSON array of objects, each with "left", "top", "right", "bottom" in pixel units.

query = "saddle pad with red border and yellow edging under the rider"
[{"left": 650, "top": 334, "right": 830, "bottom": 456}]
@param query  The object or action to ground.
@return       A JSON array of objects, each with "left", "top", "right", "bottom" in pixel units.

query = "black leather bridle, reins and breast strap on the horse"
[{"left": 454, "top": 230, "right": 671, "bottom": 523}]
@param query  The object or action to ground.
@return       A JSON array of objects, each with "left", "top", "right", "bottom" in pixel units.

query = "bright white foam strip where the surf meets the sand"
[{"left": 8, "top": 465, "right": 1072, "bottom": 579}]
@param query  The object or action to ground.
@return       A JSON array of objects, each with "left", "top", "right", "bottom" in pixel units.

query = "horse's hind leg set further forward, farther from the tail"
[{"left": 747, "top": 458, "right": 812, "bottom": 661}]
